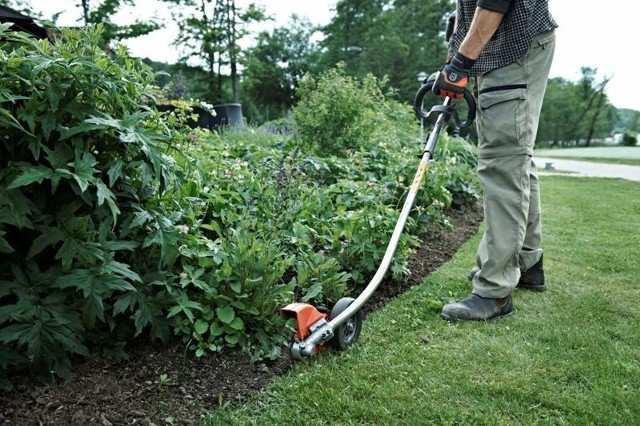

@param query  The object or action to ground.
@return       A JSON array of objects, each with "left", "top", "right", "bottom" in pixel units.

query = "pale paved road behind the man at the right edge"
[{"left": 533, "top": 156, "right": 640, "bottom": 182}]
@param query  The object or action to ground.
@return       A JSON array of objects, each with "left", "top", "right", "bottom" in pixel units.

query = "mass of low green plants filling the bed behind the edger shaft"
[{"left": 165, "top": 76, "right": 475, "bottom": 359}]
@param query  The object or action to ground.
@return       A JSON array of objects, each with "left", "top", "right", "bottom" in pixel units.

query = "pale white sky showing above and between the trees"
[{"left": 31, "top": 0, "right": 640, "bottom": 111}]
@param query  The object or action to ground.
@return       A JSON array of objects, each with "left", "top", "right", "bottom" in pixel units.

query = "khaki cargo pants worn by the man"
[{"left": 473, "top": 31, "right": 555, "bottom": 298}]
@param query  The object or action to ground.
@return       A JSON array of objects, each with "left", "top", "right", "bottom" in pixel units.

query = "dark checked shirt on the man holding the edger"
[{"left": 449, "top": 0, "right": 562, "bottom": 76}]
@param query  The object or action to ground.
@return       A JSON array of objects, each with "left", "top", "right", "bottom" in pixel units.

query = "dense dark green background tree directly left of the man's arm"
[{"left": 322, "top": 0, "right": 455, "bottom": 101}]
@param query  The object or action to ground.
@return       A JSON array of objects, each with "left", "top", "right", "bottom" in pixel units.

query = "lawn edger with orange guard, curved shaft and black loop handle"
[{"left": 280, "top": 75, "right": 476, "bottom": 360}]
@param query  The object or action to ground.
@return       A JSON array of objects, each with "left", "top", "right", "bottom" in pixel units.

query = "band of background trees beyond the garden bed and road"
[{"left": 0, "top": 0, "right": 640, "bottom": 143}]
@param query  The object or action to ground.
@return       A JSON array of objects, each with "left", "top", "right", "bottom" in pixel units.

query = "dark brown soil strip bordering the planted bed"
[{"left": 0, "top": 206, "right": 482, "bottom": 426}]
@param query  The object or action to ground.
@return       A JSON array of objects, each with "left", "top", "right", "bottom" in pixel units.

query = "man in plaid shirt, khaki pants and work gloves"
[{"left": 433, "top": 0, "right": 557, "bottom": 321}]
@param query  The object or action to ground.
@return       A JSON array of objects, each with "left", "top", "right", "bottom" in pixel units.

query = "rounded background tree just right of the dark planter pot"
[{"left": 243, "top": 15, "right": 320, "bottom": 120}]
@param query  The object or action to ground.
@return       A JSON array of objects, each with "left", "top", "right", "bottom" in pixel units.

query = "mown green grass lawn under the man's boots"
[{"left": 207, "top": 176, "right": 640, "bottom": 425}]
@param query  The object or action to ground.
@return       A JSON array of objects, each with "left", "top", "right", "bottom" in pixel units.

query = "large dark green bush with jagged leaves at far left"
[{"left": 0, "top": 25, "right": 179, "bottom": 381}]
